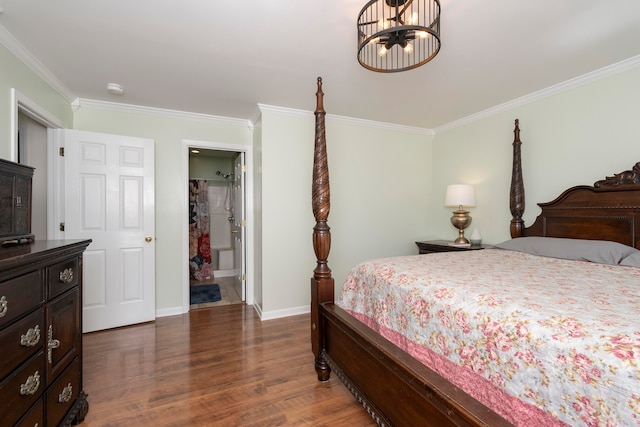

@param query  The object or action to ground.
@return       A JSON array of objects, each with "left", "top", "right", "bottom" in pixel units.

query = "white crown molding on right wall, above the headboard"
[{"left": 434, "top": 55, "right": 640, "bottom": 134}]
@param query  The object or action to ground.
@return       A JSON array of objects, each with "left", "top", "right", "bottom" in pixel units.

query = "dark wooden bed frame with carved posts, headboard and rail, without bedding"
[{"left": 311, "top": 78, "right": 640, "bottom": 427}]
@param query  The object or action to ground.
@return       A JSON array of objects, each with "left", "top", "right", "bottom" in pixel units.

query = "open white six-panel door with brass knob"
[{"left": 57, "top": 130, "right": 155, "bottom": 332}]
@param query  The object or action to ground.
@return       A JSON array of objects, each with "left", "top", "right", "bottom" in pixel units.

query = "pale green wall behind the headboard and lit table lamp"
[{"left": 431, "top": 68, "right": 640, "bottom": 243}]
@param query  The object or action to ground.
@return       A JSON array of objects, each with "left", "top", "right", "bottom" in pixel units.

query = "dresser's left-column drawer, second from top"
[{"left": 0, "top": 308, "right": 46, "bottom": 381}]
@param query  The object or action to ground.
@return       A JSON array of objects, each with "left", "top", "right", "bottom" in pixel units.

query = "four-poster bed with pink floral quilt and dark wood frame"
[{"left": 311, "top": 78, "right": 640, "bottom": 426}]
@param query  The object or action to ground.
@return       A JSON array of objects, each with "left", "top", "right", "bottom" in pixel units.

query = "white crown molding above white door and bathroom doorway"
[{"left": 72, "top": 98, "right": 253, "bottom": 129}]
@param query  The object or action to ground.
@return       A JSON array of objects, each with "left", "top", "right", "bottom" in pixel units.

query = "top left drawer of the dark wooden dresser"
[{"left": 0, "top": 271, "right": 44, "bottom": 328}]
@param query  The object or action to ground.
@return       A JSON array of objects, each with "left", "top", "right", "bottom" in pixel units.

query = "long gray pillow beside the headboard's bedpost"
[{"left": 496, "top": 237, "right": 640, "bottom": 265}]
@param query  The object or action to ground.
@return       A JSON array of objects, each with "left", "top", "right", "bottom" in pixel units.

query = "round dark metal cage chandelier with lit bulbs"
[{"left": 358, "top": 0, "right": 440, "bottom": 73}]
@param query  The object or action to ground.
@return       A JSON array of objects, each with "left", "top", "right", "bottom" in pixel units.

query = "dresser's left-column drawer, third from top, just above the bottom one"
[{"left": 0, "top": 351, "right": 45, "bottom": 425}]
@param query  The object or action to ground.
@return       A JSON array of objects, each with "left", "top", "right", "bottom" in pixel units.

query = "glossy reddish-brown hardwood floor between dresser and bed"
[{"left": 81, "top": 304, "right": 375, "bottom": 427}]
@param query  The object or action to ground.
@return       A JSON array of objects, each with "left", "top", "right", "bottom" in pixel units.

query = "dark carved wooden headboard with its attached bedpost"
[{"left": 510, "top": 119, "right": 640, "bottom": 249}]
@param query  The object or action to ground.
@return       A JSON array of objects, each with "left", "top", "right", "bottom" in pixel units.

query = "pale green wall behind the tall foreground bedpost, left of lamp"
[{"left": 261, "top": 105, "right": 432, "bottom": 312}]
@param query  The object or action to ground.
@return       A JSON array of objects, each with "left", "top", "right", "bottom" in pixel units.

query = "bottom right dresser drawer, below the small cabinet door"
[{"left": 45, "top": 358, "right": 80, "bottom": 426}]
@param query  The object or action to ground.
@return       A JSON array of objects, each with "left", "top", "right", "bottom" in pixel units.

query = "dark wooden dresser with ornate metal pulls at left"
[{"left": 0, "top": 240, "right": 91, "bottom": 427}]
